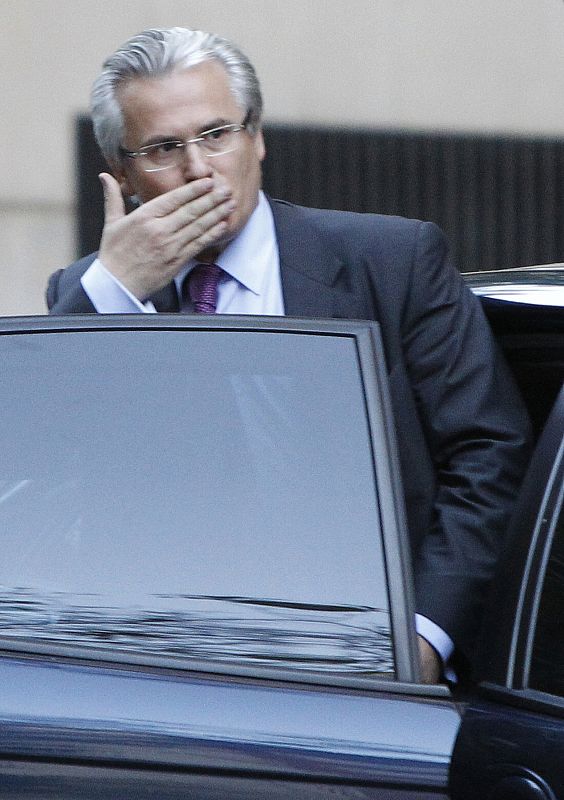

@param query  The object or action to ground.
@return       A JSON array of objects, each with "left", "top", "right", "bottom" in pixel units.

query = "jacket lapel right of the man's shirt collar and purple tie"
[{"left": 270, "top": 201, "right": 368, "bottom": 319}]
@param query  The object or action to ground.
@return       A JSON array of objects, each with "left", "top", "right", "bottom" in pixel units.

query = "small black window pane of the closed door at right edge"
[{"left": 529, "top": 484, "right": 564, "bottom": 697}]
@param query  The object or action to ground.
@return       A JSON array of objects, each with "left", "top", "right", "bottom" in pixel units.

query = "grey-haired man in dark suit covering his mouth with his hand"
[{"left": 47, "top": 28, "right": 528, "bottom": 682}]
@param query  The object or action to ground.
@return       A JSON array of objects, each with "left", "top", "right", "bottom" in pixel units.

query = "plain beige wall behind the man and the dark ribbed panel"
[{"left": 0, "top": 0, "right": 564, "bottom": 314}]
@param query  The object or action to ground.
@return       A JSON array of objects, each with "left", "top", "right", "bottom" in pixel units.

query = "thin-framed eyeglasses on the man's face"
[{"left": 120, "top": 114, "right": 249, "bottom": 172}]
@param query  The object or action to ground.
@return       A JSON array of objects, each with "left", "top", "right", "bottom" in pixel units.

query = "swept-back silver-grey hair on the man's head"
[{"left": 90, "top": 28, "right": 262, "bottom": 164}]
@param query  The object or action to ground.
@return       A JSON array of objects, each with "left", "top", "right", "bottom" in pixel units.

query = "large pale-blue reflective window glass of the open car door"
[{"left": 0, "top": 330, "right": 393, "bottom": 674}]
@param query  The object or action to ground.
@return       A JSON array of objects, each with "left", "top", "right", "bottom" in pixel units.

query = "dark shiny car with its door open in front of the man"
[{"left": 0, "top": 270, "right": 564, "bottom": 800}]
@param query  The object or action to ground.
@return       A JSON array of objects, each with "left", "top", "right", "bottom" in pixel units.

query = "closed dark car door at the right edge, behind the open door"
[{"left": 451, "top": 382, "right": 564, "bottom": 800}]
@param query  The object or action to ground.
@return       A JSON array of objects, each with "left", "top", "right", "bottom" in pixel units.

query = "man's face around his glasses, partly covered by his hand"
[{"left": 115, "top": 61, "right": 264, "bottom": 251}]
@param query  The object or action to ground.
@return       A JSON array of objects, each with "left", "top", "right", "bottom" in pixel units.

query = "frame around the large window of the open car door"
[{"left": 0, "top": 314, "right": 426, "bottom": 695}]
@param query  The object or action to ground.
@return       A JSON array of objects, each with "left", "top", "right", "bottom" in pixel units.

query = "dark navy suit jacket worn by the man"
[{"left": 47, "top": 201, "right": 529, "bottom": 654}]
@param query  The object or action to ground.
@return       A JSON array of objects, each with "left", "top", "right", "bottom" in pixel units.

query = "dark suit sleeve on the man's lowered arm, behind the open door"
[{"left": 402, "top": 223, "right": 530, "bottom": 654}]
